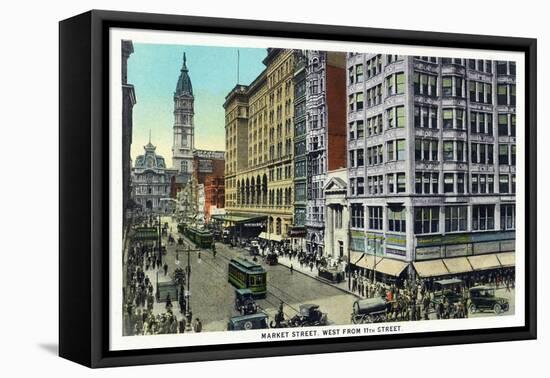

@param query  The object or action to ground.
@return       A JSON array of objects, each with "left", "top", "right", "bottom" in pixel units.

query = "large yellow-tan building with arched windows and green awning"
[{"left": 224, "top": 48, "right": 294, "bottom": 241}]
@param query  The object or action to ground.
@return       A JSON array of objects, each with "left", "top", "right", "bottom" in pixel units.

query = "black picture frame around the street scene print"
[{"left": 59, "top": 10, "right": 537, "bottom": 368}]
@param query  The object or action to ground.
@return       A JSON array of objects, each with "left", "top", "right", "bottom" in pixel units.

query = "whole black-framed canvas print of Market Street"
[{"left": 59, "top": 11, "right": 536, "bottom": 367}]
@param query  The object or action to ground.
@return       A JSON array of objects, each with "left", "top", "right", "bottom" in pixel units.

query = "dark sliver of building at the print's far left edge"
[{"left": 121, "top": 40, "right": 136, "bottom": 232}]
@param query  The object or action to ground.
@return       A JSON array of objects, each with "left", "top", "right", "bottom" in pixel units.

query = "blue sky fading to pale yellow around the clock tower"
[{"left": 128, "top": 43, "right": 266, "bottom": 166}]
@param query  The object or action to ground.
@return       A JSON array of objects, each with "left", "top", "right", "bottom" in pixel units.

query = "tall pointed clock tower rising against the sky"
[{"left": 172, "top": 53, "right": 195, "bottom": 183}]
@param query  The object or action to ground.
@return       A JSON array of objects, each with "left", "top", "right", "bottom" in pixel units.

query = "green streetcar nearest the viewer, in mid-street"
[{"left": 227, "top": 258, "right": 267, "bottom": 298}]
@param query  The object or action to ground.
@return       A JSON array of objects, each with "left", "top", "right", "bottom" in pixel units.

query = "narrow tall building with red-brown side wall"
[{"left": 305, "top": 50, "right": 346, "bottom": 255}]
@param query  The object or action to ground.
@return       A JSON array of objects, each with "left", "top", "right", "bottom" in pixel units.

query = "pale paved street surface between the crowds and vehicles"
[{"left": 135, "top": 217, "right": 515, "bottom": 331}]
